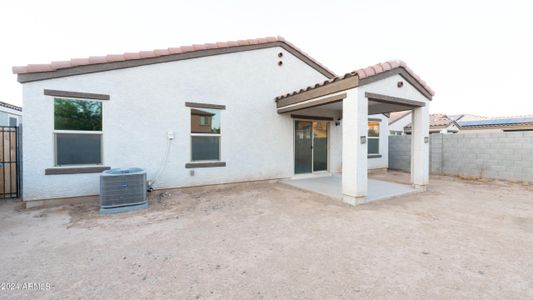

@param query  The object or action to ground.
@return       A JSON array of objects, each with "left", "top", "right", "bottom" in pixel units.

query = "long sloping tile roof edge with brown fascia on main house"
[{"left": 13, "top": 37, "right": 336, "bottom": 83}]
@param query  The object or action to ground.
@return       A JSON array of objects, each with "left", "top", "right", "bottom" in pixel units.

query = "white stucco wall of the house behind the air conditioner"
[{"left": 23, "top": 48, "right": 325, "bottom": 200}]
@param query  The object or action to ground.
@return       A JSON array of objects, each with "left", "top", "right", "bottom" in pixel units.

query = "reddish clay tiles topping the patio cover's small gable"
[{"left": 276, "top": 60, "right": 435, "bottom": 101}]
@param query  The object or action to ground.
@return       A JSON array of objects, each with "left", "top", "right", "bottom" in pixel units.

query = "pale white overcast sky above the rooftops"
[{"left": 0, "top": 0, "right": 533, "bottom": 116}]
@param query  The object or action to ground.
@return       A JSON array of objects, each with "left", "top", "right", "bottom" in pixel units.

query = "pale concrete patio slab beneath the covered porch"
[{"left": 282, "top": 174, "right": 419, "bottom": 202}]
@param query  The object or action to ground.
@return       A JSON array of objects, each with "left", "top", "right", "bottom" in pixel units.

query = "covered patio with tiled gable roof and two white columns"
[{"left": 276, "top": 61, "right": 434, "bottom": 205}]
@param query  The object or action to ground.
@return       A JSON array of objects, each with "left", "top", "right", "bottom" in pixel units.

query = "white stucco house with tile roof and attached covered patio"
[{"left": 13, "top": 38, "right": 433, "bottom": 206}]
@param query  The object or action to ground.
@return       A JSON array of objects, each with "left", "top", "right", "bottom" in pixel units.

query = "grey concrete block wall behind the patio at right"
[{"left": 389, "top": 132, "right": 533, "bottom": 182}]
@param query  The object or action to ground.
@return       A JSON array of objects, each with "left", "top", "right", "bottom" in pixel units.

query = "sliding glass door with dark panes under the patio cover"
[{"left": 294, "top": 121, "right": 328, "bottom": 174}]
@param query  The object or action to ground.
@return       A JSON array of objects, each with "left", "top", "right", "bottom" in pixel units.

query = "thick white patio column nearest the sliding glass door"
[{"left": 342, "top": 89, "right": 368, "bottom": 205}]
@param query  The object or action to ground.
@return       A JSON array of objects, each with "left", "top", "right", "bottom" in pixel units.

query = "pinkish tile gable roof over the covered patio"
[{"left": 276, "top": 60, "right": 435, "bottom": 101}]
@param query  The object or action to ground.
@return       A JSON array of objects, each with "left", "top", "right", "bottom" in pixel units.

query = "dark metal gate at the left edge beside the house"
[{"left": 0, "top": 126, "right": 20, "bottom": 199}]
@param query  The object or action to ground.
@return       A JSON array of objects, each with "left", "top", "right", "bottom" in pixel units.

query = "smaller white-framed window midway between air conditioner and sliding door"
[{"left": 191, "top": 108, "right": 221, "bottom": 161}]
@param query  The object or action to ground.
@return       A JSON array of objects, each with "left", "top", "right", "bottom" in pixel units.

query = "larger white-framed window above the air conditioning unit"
[{"left": 54, "top": 98, "right": 102, "bottom": 166}]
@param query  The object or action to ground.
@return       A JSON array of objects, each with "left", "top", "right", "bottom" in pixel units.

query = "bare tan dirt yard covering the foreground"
[{"left": 0, "top": 173, "right": 533, "bottom": 299}]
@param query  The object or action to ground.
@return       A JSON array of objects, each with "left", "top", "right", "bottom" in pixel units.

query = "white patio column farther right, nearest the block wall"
[{"left": 411, "top": 104, "right": 429, "bottom": 189}]
